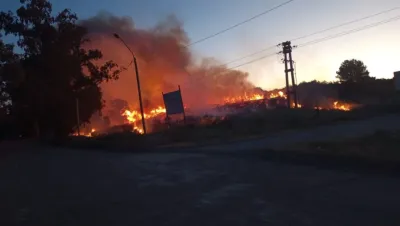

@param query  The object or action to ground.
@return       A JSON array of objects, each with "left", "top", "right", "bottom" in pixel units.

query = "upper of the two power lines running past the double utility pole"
[{"left": 223, "top": 7, "right": 400, "bottom": 65}]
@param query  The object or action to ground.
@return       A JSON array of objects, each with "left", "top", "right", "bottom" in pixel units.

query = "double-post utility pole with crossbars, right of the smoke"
[{"left": 280, "top": 41, "right": 298, "bottom": 108}]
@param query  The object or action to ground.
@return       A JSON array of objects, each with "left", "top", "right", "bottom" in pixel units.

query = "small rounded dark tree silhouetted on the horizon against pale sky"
[{"left": 336, "top": 59, "right": 370, "bottom": 83}]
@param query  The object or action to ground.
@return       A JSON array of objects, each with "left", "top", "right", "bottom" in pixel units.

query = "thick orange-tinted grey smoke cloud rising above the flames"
[{"left": 81, "top": 12, "right": 254, "bottom": 114}]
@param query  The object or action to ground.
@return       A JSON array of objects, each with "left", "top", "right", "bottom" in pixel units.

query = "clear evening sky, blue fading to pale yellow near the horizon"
[{"left": 1, "top": 0, "right": 400, "bottom": 88}]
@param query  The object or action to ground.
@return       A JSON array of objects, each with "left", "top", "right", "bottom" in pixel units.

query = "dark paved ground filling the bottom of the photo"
[{"left": 0, "top": 145, "right": 400, "bottom": 226}]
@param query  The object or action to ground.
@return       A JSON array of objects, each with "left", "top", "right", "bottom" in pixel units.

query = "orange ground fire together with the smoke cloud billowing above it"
[{"left": 74, "top": 13, "right": 351, "bottom": 135}]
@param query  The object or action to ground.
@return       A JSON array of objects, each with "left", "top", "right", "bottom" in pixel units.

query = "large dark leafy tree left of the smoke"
[{"left": 0, "top": 0, "right": 121, "bottom": 135}]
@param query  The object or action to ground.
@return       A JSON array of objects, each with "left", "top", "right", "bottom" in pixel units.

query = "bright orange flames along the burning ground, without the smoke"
[{"left": 76, "top": 91, "right": 352, "bottom": 136}]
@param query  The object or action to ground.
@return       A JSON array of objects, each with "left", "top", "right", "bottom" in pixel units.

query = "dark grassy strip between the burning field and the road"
[{"left": 58, "top": 105, "right": 400, "bottom": 151}]
